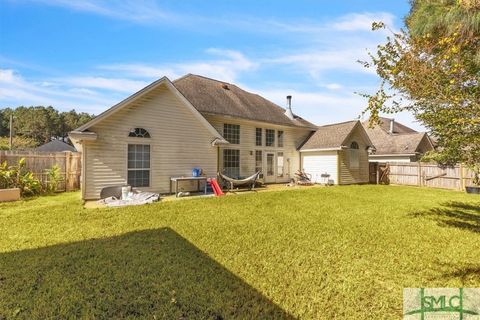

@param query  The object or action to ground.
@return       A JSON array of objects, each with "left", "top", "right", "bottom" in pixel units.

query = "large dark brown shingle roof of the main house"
[{"left": 173, "top": 74, "right": 316, "bottom": 129}]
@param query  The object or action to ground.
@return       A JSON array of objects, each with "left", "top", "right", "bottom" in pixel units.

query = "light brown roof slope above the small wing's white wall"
[{"left": 300, "top": 120, "right": 361, "bottom": 151}]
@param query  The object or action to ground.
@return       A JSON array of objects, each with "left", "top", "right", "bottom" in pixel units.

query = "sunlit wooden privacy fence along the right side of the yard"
[{"left": 378, "top": 162, "right": 473, "bottom": 190}]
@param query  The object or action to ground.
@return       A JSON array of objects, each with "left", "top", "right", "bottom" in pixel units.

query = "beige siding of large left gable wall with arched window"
[{"left": 83, "top": 86, "right": 217, "bottom": 199}]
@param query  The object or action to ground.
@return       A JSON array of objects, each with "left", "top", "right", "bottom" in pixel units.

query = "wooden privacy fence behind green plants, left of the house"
[{"left": 0, "top": 151, "right": 82, "bottom": 191}]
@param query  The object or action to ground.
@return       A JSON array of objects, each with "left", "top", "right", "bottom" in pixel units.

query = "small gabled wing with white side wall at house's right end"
[{"left": 300, "top": 121, "right": 373, "bottom": 184}]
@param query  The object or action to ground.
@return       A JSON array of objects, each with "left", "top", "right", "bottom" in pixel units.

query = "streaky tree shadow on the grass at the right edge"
[{"left": 413, "top": 201, "right": 480, "bottom": 233}]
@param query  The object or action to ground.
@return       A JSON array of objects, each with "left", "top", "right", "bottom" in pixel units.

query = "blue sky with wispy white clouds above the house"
[{"left": 0, "top": 0, "right": 420, "bottom": 128}]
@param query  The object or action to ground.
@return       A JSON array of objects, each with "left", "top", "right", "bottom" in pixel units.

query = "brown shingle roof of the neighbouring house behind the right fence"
[{"left": 362, "top": 118, "right": 428, "bottom": 155}]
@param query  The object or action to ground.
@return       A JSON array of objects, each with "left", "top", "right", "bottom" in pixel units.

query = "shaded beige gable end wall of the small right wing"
[{"left": 338, "top": 127, "right": 369, "bottom": 184}]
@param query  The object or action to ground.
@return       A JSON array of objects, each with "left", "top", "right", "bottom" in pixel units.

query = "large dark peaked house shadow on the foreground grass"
[{"left": 0, "top": 228, "right": 293, "bottom": 319}]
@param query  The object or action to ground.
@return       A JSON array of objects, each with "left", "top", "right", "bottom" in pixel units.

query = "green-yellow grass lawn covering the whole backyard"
[{"left": 0, "top": 186, "right": 480, "bottom": 319}]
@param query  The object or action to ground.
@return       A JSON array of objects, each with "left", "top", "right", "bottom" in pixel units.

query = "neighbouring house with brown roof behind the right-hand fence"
[{"left": 363, "top": 117, "right": 434, "bottom": 162}]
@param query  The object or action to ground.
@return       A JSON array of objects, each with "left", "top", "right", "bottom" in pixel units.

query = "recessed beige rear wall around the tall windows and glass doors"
[{"left": 205, "top": 115, "right": 311, "bottom": 182}]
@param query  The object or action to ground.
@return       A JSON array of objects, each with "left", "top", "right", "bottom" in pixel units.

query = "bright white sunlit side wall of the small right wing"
[{"left": 302, "top": 152, "right": 337, "bottom": 184}]
